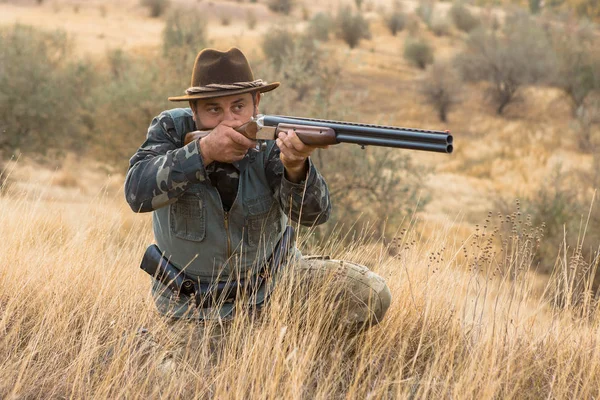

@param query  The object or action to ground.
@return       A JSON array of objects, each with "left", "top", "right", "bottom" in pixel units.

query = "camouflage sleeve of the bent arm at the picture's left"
[{"left": 125, "top": 112, "right": 207, "bottom": 212}]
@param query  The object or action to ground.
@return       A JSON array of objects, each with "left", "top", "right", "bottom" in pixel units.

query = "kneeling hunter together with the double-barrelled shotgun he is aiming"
[{"left": 125, "top": 48, "right": 452, "bottom": 329}]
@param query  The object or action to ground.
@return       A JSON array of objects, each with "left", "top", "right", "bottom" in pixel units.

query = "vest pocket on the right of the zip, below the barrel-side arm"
[{"left": 246, "top": 195, "right": 281, "bottom": 247}]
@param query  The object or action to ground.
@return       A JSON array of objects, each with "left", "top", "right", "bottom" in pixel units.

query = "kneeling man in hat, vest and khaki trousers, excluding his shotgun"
[{"left": 125, "top": 48, "right": 390, "bottom": 326}]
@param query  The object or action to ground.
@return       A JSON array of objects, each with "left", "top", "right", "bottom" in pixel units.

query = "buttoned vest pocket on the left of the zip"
[{"left": 170, "top": 190, "right": 206, "bottom": 242}]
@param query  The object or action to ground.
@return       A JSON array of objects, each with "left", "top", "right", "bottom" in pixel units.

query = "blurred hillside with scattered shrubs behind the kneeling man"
[{"left": 0, "top": 0, "right": 600, "bottom": 280}]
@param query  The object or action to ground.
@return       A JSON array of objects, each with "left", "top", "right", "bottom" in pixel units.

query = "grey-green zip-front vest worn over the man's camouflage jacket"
[{"left": 152, "top": 110, "right": 287, "bottom": 282}]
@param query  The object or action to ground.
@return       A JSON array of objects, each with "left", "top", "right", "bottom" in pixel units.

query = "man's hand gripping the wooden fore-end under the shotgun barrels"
[{"left": 276, "top": 129, "right": 329, "bottom": 183}]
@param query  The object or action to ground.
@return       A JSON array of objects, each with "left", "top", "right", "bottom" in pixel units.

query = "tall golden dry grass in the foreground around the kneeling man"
[{"left": 0, "top": 164, "right": 600, "bottom": 399}]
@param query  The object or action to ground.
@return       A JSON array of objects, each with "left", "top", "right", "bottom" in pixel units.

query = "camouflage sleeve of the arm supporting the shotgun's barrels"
[{"left": 266, "top": 144, "right": 331, "bottom": 226}]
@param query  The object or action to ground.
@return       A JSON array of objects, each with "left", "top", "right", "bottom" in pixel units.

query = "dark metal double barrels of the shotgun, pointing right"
[{"left": 263, "top": 115, "right": 454, "bottom": 153}]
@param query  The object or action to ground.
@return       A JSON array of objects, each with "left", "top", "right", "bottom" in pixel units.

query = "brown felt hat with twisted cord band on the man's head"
[{"left": 169, "top": 47, "right": 279, "bottom": 101}]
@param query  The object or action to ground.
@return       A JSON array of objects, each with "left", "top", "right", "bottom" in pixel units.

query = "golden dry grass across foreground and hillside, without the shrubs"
[{"left": 0, "top": 0, "right": 600, "bottom": 399}]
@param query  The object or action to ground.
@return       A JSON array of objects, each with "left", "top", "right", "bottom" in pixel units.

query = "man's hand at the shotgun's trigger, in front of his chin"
[{"left": 185, "top": 120, "right": 256, "bottom": 167}]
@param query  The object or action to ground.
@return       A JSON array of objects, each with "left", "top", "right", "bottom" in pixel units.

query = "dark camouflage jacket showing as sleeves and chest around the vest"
[{"left": 125, "top": 108, "right": 331, "bottom": 222}]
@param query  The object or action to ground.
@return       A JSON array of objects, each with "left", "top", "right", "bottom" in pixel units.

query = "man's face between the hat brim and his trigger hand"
[{"left": 191, "top": 93, "right": 260, "bottom": 130}]
